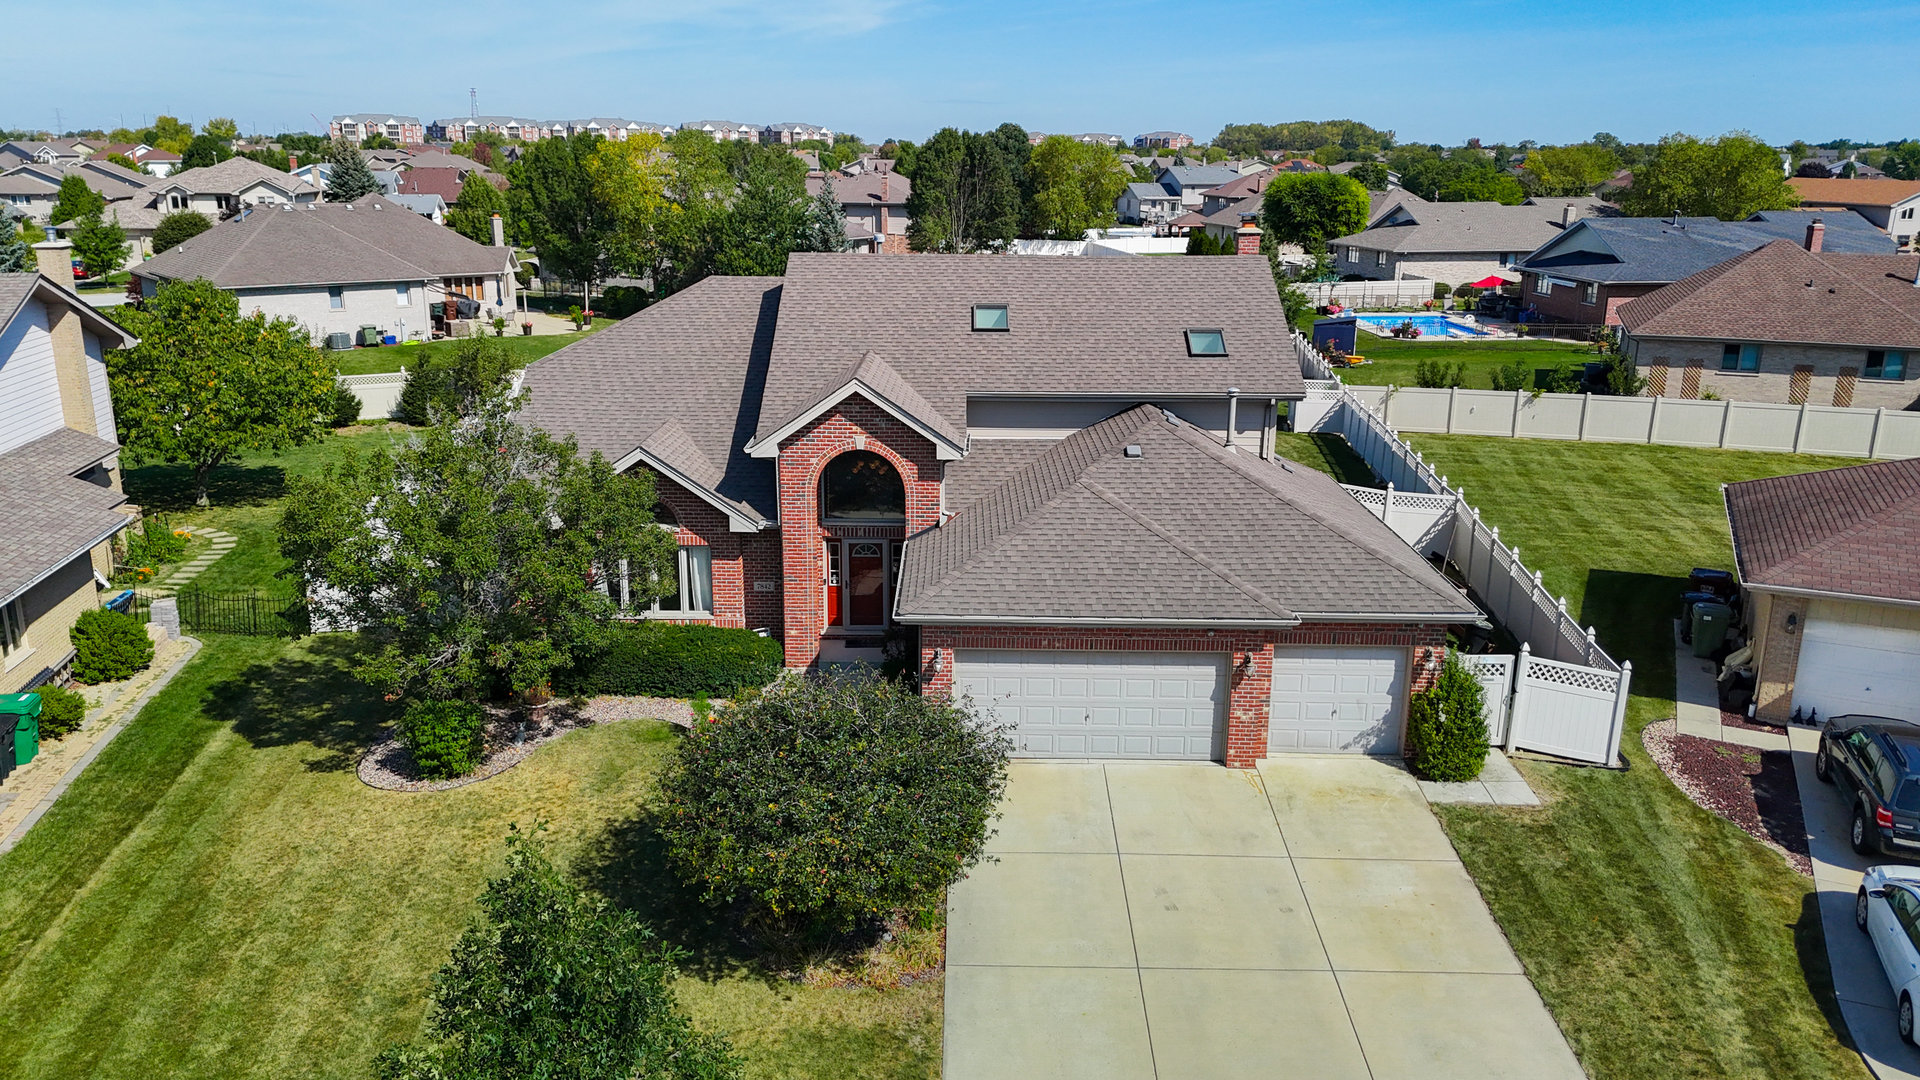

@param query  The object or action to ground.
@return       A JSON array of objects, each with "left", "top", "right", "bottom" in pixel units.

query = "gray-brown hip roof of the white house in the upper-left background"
[{"left": 132, "top": 196, "right": 513, "bottom": 288}]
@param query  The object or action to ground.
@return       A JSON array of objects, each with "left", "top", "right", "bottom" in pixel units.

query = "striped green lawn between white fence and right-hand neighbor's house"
[{"left": 1413, "top": 436, "right": 1866, "bottom": 1080}]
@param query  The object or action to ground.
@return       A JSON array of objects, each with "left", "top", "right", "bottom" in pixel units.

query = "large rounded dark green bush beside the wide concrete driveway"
[{"left": 660, "top": 675, "right": 1012, "bottom": 930}]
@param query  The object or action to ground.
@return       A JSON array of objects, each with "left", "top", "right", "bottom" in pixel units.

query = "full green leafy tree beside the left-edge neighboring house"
[{"left": 108, "top": 281, "right": 334, "bottom": 505}]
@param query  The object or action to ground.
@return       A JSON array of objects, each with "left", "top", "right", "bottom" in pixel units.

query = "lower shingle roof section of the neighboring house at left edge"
[{"left": 0, "top": 429, "right": 127, "bottom": 603}]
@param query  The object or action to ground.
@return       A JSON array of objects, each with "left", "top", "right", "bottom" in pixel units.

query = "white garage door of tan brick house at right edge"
[{"left": 1793, "top": 619, "right": 1920, "bottom": 721}]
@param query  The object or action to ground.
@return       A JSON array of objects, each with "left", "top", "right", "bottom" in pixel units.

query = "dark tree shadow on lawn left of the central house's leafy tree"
[{"left": 207, "top": 634, "right": 392, "bottom": 773}]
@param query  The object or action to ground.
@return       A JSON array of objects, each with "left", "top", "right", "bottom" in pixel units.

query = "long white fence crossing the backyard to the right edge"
[{"left": 1319, "top": 380, "right": 1920, "bottom": 457}]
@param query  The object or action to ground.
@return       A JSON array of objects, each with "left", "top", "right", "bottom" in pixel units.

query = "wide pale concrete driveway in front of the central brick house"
[{"left": 945, "top": 755, "right": 1584, "bottom": 1080}]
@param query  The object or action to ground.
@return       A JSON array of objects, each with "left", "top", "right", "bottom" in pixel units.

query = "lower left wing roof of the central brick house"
[{"left": 520, "top": 277, "right": 781, "bottom": 521}]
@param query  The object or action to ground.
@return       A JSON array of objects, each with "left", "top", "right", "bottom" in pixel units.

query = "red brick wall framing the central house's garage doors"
[{"left": 920, "top": 623, "right": 1446, "bottom": 769}]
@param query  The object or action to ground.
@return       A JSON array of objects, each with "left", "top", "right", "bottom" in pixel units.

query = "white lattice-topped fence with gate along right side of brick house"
[{"left": 1294, "top": 334, "right": 1634, "bottom": 765}]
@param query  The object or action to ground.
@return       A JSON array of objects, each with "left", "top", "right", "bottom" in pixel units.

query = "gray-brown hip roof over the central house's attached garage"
[{"left": 895, "top": 405, "right": 1480, "bottom": 626}]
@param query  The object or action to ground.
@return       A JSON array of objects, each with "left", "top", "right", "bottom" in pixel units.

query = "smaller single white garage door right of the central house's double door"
[{"left": 1267, "top": 648, "right": 1407, "bottom": 753}]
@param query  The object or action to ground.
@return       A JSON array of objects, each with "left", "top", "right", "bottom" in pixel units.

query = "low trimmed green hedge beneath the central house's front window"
[{"left": 561, "top": 623, "right": 785, "bottom": 698}]
